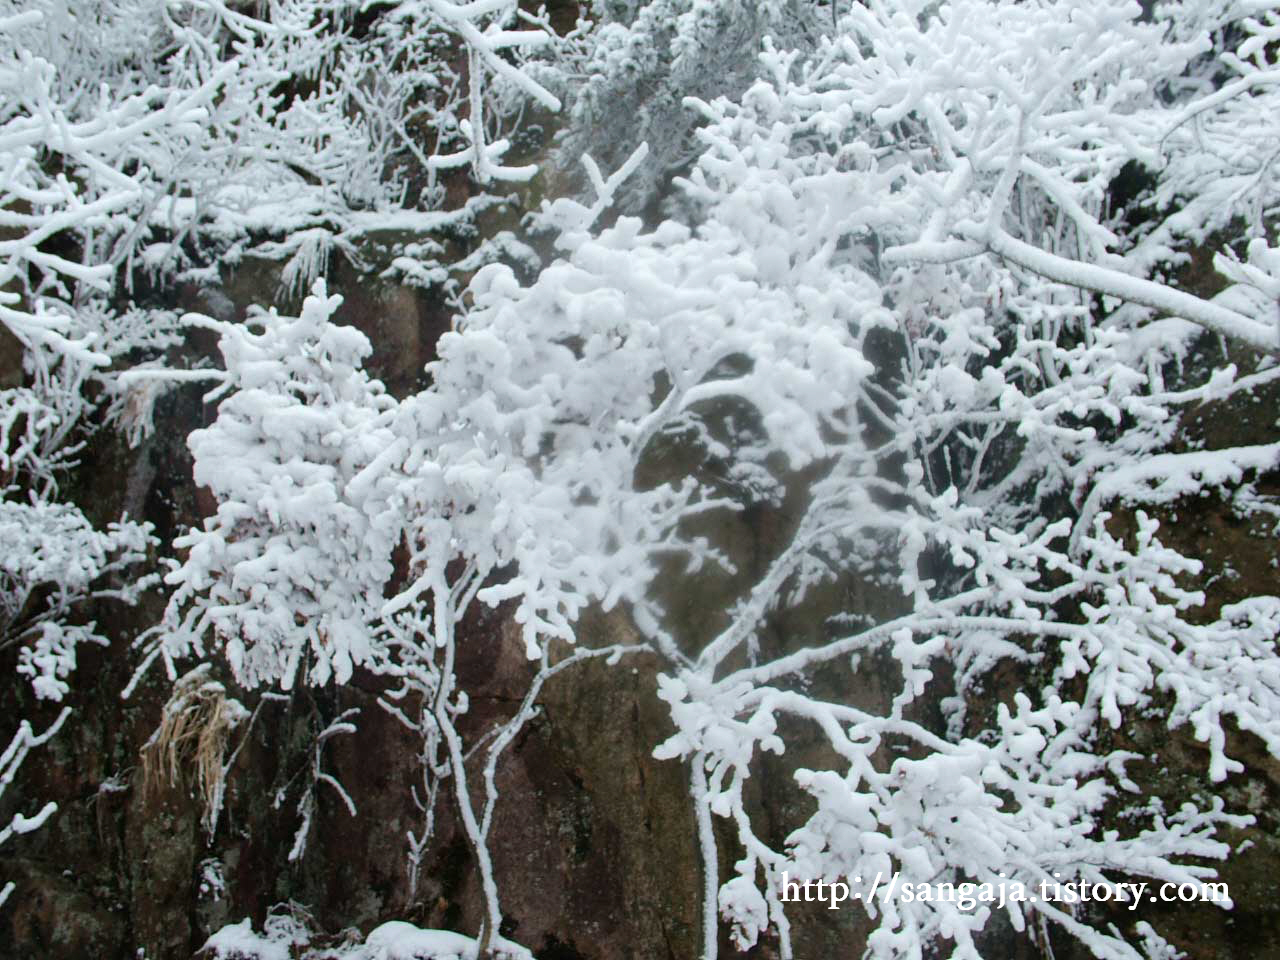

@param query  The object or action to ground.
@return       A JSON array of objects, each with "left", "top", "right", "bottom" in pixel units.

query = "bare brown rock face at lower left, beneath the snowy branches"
[{"left": 0, "top": 616, "right": 699, "bottom": 960}]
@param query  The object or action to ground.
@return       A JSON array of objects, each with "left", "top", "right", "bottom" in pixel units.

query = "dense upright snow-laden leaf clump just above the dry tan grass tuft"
[{"left": 168, "top": 280, "right": 399, "bottom": 687}]
